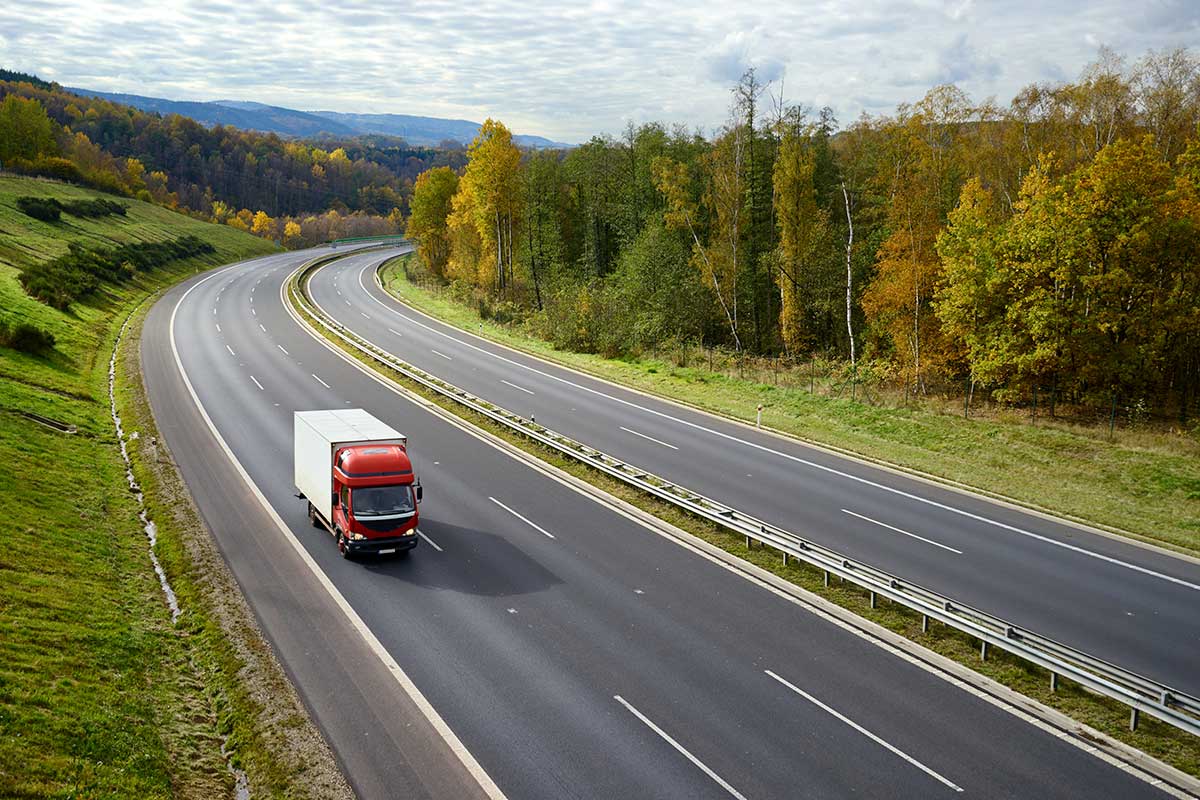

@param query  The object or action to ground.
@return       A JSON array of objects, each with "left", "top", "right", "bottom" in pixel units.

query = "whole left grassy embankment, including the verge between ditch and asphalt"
[{"left": 0, "top": 178, "right": 348, "bottom": 799}]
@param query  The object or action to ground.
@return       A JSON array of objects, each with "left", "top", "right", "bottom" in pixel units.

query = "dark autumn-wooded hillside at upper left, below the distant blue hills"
[{"left": 0, "top": 71, "right": 466, "bottom": 246}]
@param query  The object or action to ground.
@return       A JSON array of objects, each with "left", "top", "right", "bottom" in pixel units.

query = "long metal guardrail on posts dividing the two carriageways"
[{"left": 288, "top": 259, "right": 1200, "bottom": 736}]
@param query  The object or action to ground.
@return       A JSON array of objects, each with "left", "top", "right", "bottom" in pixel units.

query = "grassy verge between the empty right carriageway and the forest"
[{"left": 382, "top": 255, "right": 1200, "bottom": 555}]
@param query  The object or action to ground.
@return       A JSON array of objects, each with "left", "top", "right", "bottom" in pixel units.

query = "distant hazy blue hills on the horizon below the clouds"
[{"left": 66, "top": 88, "right": 571, "bottom": 149}]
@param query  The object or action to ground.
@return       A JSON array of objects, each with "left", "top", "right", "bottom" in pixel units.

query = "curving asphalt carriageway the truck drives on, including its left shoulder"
[{"left": 143, "top": 247, "right": 1176, "bottom": 799}]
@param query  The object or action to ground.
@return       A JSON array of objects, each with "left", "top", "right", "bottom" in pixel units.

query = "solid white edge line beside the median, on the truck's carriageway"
[{"left": 295, "top": 261, "right": 1200, "bottom": 800}]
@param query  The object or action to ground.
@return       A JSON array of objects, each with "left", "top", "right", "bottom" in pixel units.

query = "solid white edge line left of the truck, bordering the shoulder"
[{"left": 168, "top": 264, "right": 505, "bottom": 800}]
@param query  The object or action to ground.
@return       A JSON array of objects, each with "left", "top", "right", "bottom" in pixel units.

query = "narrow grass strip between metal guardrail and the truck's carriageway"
[{"left": 298, "top": 266, "right": 1200, "bottom": 776}]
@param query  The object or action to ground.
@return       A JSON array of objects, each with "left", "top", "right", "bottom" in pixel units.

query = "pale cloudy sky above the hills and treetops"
[{"left": 0, "top": 0, "right": 1200, "bottom": 142}]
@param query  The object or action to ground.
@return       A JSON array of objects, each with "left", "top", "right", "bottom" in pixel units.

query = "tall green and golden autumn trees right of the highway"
[{"left": 408, "top": 49, "right": 1200, "bottom": 417}]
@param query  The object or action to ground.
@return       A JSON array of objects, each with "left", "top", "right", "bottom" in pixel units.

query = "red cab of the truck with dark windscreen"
[{"left": 331, "top": 444, "right": 421, "bottom": 554}]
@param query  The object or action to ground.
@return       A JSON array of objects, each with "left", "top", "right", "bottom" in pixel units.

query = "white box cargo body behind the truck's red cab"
[{"left": 294, "top": 408, "right": 408, "bottom": 522}]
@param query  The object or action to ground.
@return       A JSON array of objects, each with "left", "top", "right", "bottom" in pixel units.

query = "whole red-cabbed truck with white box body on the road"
[{"left": 294, "top": 409, "right": 421, "bottom": 558}]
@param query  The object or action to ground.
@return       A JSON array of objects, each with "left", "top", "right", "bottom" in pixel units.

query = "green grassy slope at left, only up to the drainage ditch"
[{"left": 0, "top": 178, "right": 272, "bottom": 798}]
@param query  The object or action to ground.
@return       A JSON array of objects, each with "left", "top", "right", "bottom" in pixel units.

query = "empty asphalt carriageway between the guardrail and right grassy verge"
[{"left": 310, "top": 251, "right": 1200, "bottom": 693}]
